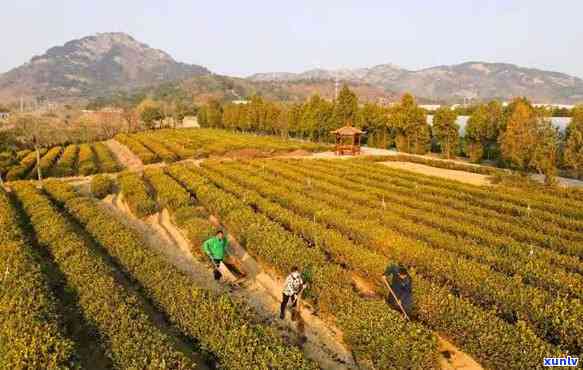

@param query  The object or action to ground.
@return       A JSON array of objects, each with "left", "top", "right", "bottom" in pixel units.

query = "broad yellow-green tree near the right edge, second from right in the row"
[{"left": 500, "top": 100, "right": 558, "bottom": 183}]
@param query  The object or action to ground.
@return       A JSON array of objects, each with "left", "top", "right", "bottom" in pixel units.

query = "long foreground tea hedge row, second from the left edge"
[{"left": 15, "top": 182, "right": 196, "bottom": 369}]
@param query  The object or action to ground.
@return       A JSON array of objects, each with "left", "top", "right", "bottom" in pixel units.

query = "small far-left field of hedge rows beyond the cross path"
[{"left": 0, "top": 142, "right": 123, "bottom": 181}]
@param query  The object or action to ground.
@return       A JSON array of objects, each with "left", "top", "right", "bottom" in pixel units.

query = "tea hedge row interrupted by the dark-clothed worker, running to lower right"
[{"left": 205, "top": 160, "right": 559, "bottom": 368}]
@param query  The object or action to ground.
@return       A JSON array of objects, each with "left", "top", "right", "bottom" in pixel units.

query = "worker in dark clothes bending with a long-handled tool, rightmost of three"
[{"left": 383, "top": 264, "right": 413, "bottom": 316}]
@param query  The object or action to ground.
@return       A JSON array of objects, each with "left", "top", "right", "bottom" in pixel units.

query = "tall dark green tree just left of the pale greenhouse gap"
[{"left": 389, "top": 93, "right": 431, "bottom": 154}]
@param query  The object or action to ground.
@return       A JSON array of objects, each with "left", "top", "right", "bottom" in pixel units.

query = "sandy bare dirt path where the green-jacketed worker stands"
[{"left": 104, "top": 195, "right": 357, "bottom": 369}]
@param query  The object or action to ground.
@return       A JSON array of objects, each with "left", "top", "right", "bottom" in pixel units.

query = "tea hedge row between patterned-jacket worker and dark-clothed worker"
[{"left": 168, "top": 166, "right": 436, "bottom": 369}]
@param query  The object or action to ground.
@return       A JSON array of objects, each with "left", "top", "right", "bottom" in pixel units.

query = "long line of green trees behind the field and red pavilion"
[{"left": 197, "top": 85, "right": 583, "bottom": 182}]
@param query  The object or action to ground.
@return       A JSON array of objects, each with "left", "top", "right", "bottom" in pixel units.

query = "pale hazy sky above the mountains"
[{"left": 0, "top": 0, "right": 583, "bottom": 77}]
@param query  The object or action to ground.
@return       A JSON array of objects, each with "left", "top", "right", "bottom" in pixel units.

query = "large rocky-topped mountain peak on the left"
[{"left": 0, "top": 33, "right": 210, "bottom": 100}]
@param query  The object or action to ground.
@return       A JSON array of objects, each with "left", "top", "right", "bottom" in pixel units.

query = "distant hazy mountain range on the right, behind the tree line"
[{"left": 248, "top": 62, "right": 583, "bottom": 103}]
